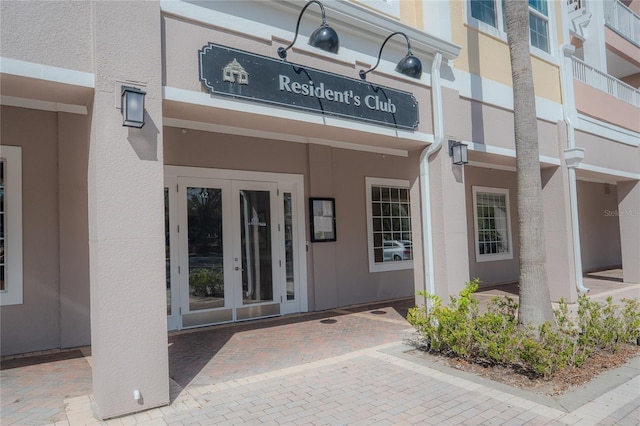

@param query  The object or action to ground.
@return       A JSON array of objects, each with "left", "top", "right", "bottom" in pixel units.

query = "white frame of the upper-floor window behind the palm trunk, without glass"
[{"left": 464, "top": 0, "right": 557, "bottom": 60}]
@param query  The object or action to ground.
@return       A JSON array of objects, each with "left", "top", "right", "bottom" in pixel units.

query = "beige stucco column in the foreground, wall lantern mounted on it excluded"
[{"left": 88, "top": 1, "right": 169, "bottom": 419}]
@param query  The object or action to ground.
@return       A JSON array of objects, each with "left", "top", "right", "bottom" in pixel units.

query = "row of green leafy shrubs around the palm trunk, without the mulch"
[{"left": 407, "top": 278, "right": 640, "bottom": 378}]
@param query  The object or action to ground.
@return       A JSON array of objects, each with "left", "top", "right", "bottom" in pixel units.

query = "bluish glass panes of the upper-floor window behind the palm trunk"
[{"left": 467, "top": 0, "right": 550, "bottom": 53}]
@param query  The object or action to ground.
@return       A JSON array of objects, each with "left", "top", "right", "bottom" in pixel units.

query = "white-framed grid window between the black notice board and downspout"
[{"left": 365, "top": 178, "right": 413, "bottom": 272}]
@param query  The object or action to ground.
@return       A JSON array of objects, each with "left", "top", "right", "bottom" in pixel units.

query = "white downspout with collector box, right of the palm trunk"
[{"left": 559, "top": 44, "right": 589, "bottom": 294}]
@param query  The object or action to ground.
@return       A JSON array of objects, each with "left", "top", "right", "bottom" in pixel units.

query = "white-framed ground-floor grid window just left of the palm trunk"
[{"left": 473, "top": 186, "right": 513, "bottom": 262}]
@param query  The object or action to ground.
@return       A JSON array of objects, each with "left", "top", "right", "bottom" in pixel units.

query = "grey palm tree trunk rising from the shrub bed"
[{"left": 505, "top": 0, "right": 554, "bottom": 326}]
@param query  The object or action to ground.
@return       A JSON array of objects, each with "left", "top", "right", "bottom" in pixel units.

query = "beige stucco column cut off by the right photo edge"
[{"left": 618, "top": 180, "right": 640, "bottom": 283}]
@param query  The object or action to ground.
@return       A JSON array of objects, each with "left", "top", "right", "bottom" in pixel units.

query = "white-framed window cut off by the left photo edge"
[{"left": 0, "top": 145, "right": 22, "bottom": 305}]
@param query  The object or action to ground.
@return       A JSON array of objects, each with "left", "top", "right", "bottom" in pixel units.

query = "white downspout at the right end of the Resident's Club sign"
[{"left": 420, "top": 52, "right": 444, "bottom": 309}]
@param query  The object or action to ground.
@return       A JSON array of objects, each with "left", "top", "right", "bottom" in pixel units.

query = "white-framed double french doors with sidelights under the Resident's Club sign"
[{"left": 169, "top": 170, "right": 304, "bottom": 328}]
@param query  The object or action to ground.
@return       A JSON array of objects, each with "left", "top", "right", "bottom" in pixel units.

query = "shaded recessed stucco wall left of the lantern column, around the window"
[{"left": 0, "top": 106, "right": 90, "bottom": 355}]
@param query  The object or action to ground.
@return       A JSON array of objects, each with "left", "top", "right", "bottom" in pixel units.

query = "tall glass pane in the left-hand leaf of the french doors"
[{"left": 187, "top": 187, "right": 224, "bottom": 311}]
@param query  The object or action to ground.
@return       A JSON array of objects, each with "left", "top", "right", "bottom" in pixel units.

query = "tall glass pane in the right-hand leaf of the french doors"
[{"left": 240, "top": 190, "right": 273, "bottom": 305}]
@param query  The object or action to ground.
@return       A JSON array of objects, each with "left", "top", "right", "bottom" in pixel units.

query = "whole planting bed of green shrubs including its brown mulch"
[{"left": 407, "top": 279, "right": 640, "bottom": 394}]
